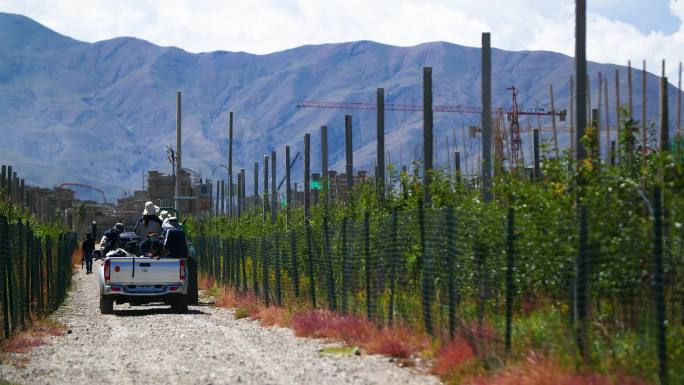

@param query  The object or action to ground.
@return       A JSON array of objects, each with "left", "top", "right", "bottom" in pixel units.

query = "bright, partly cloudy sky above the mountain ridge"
[{"left": 0, "top": 0, "right": 684, "bottom": 79}]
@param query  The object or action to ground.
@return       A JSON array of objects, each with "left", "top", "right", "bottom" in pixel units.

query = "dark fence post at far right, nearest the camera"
[{"left": 653, "top": 185, "right": 668, "bottom": 385}]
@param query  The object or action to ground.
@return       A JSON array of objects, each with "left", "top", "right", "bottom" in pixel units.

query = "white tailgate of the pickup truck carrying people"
[{"left": 109, "top": 257, "right": 180, "bottom": 285}]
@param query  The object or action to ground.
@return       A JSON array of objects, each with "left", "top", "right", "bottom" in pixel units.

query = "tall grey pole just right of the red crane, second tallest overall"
[{"left": 482, "top": 32, "right": 492, "bottom": 202}]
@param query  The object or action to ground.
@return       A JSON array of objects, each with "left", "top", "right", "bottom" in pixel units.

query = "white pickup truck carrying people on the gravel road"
[{"left": 99, "top": 249, "right": 188, "bottom": 314}]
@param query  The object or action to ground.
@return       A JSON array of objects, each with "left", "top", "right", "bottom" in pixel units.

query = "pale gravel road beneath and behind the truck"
[{"left": 0, "top": 270, "right": 439, "bottom": 384}]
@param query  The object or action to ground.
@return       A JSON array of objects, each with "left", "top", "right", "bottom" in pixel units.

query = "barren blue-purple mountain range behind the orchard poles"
[{"left": 0, "top": 13, "right": 677, "bottom": 199}]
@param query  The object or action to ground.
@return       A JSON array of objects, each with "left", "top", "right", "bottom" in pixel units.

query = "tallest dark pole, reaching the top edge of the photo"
[{"left": 575, "top": 0, "right": 588, "bottom": 165}]
